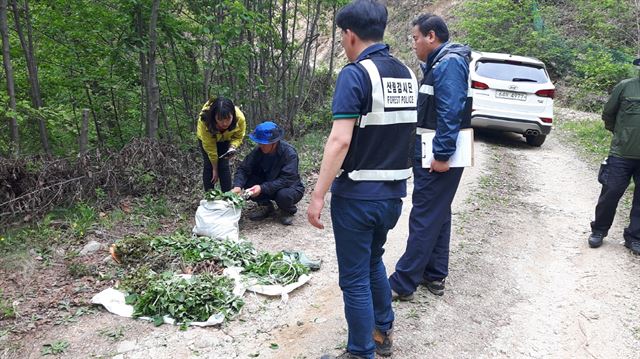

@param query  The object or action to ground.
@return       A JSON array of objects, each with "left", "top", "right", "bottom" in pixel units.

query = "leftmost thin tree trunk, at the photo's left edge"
[{"left": 0, "top": 0, "right": 20, "bottom": 156}]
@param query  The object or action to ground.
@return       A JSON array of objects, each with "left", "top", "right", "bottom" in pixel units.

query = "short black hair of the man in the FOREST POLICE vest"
[{"left": 336, "top": 0, "right": 388, "bottom": 41}]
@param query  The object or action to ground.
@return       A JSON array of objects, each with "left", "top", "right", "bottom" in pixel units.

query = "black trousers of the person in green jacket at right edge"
[{"left": 591, "top": 156, "right": 640, "bottom": 241}]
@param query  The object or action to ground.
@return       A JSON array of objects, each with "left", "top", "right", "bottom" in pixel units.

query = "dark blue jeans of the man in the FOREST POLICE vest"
[{"left": 331, "top": 195, "right": 402, "bottom": 359}]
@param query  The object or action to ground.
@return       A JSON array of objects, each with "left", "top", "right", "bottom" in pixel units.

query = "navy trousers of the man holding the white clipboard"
[{"left": 389, "top": 160, "right": 464, "bottom": 294}]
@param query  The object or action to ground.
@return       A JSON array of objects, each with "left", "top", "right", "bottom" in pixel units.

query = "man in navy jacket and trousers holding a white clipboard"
[{"left": 389, "top": 14, "right": 471, "bottom": 300}]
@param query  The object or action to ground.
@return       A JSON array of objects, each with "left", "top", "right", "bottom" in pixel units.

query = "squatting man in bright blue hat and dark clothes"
[{"left": 231, "top": 121, "right": 304, "bottom": 225}]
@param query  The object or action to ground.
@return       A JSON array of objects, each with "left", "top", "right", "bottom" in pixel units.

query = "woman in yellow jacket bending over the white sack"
[{"left": 197, "top": 97, "right": 247, "bottom": 192}]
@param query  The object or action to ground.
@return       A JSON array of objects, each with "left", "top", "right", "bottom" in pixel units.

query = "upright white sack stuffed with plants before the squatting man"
[{"left": 193, "top": 199, "right": 242, "bottom": 242}]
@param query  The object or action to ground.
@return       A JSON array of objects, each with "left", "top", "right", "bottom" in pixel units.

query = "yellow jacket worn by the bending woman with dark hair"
[{"left": 196, "top": 101, "right": 247, "bottom": 164}]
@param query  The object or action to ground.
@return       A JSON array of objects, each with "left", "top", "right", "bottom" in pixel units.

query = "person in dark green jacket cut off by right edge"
[{"left": 588, "top": 58, "right": 640, "bottom": 255}]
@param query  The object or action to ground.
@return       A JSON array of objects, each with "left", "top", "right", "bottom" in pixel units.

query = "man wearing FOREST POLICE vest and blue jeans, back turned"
[{"left": 307, "top": 0, "right": 418, "bottom": 359}]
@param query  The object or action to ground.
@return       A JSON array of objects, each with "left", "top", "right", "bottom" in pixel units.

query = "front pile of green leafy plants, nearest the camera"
[{"left": 127, "top": 272, "right": 244, "bottom": 325}]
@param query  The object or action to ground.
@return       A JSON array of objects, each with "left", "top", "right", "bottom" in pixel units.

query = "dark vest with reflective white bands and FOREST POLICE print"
[{"left": 342, "top": 56, "right": 418, "bottom": 181}]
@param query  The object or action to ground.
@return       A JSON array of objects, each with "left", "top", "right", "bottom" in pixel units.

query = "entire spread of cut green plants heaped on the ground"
[{"left": 114, "top": 233, "right": 309, "bottom": 326}]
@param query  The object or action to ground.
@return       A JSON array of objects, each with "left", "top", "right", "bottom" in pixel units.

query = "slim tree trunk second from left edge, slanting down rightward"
[{"left": 11, "top": 0, "right": 51, "bottom": 155}]
